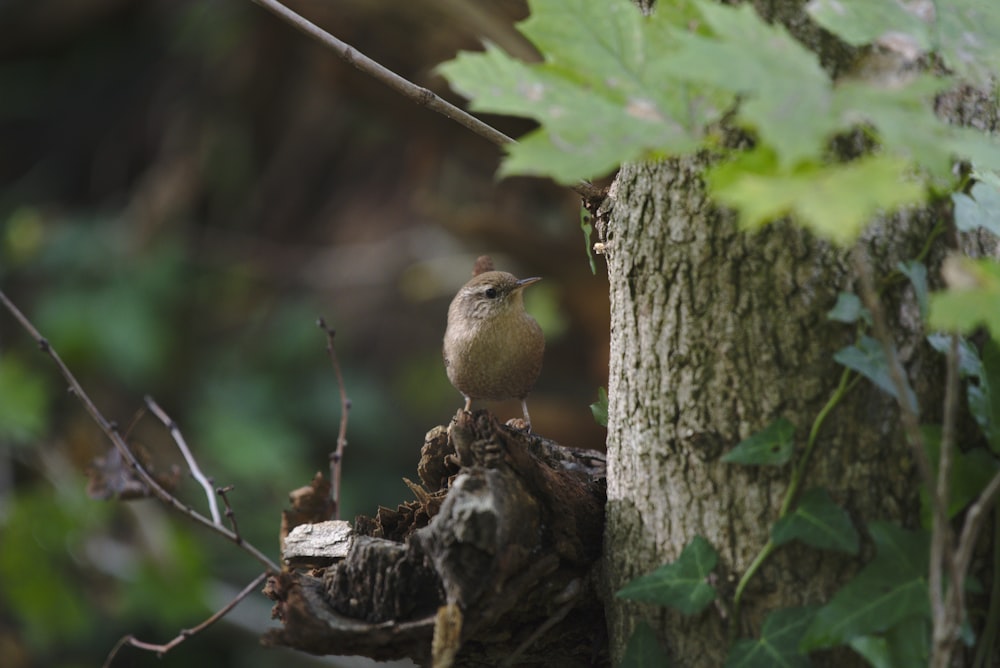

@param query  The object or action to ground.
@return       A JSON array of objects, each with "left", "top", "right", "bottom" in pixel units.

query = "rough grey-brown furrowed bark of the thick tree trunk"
[{"left": 604, "top": 2, "right": 996, "bottom": 666}]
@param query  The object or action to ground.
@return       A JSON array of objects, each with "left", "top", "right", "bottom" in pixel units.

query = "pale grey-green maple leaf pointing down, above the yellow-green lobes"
[{"left": 660, "top": 2, "right": 835, "bottom": 169}]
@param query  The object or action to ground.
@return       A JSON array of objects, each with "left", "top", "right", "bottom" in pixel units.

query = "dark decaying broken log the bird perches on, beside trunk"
[{"left": 264, "top": 411, "right": 608, "bottom": 666}]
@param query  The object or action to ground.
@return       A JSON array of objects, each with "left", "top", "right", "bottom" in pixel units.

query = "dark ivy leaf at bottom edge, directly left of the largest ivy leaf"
[{"left": 725, "top": 606, "right": 817, "bottom": 668}]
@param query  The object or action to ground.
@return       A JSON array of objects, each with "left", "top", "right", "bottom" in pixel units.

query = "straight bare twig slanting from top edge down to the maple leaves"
[{"left": 246, "top": 0, "right": 605, "bottom": 202}]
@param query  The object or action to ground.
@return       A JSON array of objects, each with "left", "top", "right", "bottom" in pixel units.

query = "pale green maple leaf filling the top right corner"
[{"left": 806, "top": 0, "right": 1000, "bottom": 86}]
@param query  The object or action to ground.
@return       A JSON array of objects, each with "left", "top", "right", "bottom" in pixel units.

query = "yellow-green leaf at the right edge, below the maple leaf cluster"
[{"left": 927, "top": 257, "right": 1000, "bottom": 339}]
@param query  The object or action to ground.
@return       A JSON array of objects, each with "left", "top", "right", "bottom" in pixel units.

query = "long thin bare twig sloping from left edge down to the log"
[{"left": 0, "top": 290, "right": 281, "bottom": 573}]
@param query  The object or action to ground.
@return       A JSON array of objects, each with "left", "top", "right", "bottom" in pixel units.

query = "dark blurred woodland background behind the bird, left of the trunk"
[{"left": 0, "top": 0, "right": 608, "bottom": 668}]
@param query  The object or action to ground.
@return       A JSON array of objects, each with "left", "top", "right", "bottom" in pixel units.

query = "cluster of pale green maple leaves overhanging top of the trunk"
[{"left": 441, "top": 0, "right": 1000, "bottom": 244}]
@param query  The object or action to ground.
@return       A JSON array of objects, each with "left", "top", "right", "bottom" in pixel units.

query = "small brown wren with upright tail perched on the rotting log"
[{"left": 444, "top": 256, "right": 545, "bottom": 431}]
